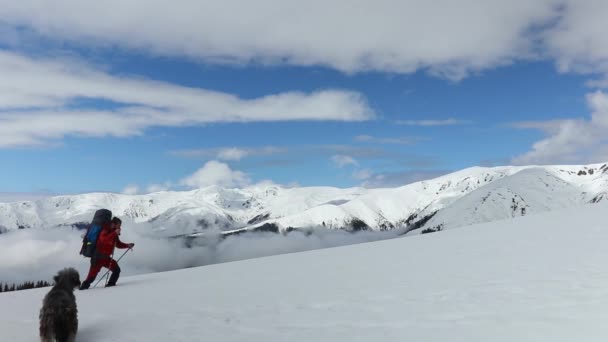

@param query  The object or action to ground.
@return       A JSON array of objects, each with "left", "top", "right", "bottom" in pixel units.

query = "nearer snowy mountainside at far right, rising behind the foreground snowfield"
[{"left": 416, "top": 165, "right": 608, "bottom": 234}]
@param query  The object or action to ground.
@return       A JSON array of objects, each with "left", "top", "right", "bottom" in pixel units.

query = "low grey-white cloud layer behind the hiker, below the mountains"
[{"left": 0, "top": 223, "right": 398, "bottom": 282}]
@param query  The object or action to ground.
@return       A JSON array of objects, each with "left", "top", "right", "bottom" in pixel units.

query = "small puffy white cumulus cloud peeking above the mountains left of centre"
[{"left": 180, "top": 160, "right": 251, "bottom": 188}]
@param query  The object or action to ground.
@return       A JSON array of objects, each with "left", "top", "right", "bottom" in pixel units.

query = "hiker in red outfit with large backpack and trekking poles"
[{"left": 80, "top": 217, "right": 135, "bottom": 290}]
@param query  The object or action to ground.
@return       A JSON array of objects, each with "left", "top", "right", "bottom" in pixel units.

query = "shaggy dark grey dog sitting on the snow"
[{"left": 40, "top": 268, "right": 80, "bottom": 342}]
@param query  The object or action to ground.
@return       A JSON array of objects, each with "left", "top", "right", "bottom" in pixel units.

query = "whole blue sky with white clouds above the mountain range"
[{"left": 0, "top": 1, "right": 608, "bottom": 194}]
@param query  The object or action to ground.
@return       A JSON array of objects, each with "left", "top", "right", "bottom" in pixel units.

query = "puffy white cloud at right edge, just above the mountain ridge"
[{"left": 512, "top": 91, "right": 608, "bottom": 165}]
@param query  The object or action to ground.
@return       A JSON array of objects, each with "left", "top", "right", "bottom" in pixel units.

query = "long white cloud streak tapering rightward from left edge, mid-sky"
[{"left": 0, "top": 51, "right": 374, "bottom": 148}]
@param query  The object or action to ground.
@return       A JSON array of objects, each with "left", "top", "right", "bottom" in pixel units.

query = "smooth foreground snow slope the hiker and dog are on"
[{"left": 0, "top": 203, "right": 608, "bottom": 342}]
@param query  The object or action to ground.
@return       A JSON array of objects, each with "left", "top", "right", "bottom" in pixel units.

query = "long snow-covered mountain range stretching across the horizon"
[{"left": 0, "top": 164, "right": 608, "bottom": 236}]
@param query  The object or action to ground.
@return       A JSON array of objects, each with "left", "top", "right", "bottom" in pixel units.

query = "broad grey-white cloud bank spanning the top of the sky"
[{"left": 0, "top": 0, "right": 560, "bottom": 79}]
